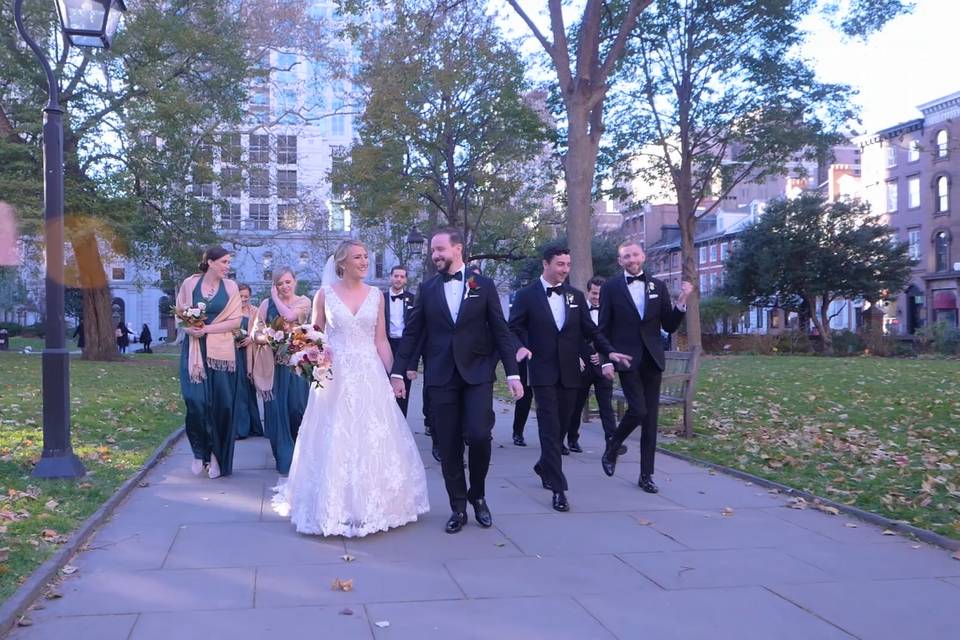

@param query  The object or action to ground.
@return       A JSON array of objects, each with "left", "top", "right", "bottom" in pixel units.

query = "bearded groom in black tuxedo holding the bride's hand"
[{"left": 390, "top": 229, "right": 523, "bottom": 533}]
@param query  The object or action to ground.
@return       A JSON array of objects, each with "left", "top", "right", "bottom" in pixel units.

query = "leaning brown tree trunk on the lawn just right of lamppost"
[{"left": 71, "top": 232, "right": 117, "bottom": 360}]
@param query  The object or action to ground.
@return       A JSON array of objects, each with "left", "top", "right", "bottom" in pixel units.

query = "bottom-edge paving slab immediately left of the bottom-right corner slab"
[{"left": 577, "top": 587, "right": 852, "bottom": 640}]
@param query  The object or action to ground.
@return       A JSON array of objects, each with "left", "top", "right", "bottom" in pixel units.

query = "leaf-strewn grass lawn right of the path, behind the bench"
[{"left": 660, "top": 356, "right": 960, "bottom": 538}]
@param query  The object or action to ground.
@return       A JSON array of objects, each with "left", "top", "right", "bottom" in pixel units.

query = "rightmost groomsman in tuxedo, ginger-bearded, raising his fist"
[{"left": 600, "top": 241, "right": 693, "bottom": 493}]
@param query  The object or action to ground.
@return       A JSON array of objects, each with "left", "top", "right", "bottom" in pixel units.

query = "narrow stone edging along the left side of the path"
[{"left": 0, "top": 427, "right": 184, "bottom": 637}]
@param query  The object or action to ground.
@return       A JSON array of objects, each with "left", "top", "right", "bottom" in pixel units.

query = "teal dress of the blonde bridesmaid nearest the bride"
[{"left": 263, "top": 300, "right": 310, "bottom": 475}]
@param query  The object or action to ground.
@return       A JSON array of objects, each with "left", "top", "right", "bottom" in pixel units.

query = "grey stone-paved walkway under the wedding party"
[{"left": 9, "top": 388, "right": 960, "bottom": 640}]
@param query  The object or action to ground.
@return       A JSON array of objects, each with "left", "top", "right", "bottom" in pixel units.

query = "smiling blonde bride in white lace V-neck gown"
[{"left": 273, "top": 240, "right": 430, "bottom": 537}]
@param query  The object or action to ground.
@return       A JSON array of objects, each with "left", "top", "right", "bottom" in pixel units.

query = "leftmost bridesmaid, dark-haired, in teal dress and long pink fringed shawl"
[{"left": 177, "top": 247, "right": 241, "bottom": 478}]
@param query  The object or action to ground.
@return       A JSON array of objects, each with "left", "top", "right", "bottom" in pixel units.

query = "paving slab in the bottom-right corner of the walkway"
[{"left": 772, "top": 579, "right": 960, "bottom": 640}]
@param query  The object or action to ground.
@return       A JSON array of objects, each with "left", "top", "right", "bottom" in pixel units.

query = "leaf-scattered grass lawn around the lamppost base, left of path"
[{"left": 0, "top": 352, "right": 183, "bottom": 600}]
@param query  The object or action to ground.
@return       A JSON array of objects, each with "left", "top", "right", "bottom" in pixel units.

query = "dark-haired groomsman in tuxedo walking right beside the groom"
[{"left": 509, "top": 247, "right": 630, "bottom": 511}]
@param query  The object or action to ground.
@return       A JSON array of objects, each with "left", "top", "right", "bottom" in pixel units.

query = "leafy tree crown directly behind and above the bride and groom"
[{"left": 331, "top": 2, "right": 551, "bottom": 259}]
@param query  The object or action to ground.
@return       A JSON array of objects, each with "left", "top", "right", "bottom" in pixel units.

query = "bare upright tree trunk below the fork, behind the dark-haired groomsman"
[{"left": 564, "top": 107, "right": 599, "bottom": 291}]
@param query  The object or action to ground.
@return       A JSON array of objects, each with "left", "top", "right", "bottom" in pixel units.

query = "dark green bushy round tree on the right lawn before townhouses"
[{"left": 725, "top": 194, "right": 914, "bottom": 348}]
